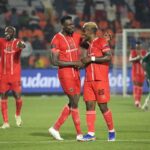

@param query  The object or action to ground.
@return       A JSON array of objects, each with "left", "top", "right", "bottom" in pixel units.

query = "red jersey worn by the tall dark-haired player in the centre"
[{"left": 51, "top": 32, "right": 80, "bottom": 78}]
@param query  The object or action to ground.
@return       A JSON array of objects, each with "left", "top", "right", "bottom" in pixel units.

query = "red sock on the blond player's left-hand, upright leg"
[{"left": 86, "top": 110, "right": 96, "bottom": 132}]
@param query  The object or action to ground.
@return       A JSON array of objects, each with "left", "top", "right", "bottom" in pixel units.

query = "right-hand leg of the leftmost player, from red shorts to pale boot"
[{"left": 11, "top": 81, "right": 23, "bottom": 127}]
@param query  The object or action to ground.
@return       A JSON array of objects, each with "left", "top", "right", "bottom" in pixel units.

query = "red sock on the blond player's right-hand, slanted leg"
[{"left": 103, "top": 110, "right": 114, "bottom": 130}]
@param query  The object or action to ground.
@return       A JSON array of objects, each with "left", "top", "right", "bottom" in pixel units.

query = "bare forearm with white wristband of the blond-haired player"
[{"left": 81, "top": 51, "right": 112, "bottom": 64}]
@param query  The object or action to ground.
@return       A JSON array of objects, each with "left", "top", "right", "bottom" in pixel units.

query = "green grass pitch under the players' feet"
[{"left": 0, "top": 96, "right": 150, "bottom": 150}]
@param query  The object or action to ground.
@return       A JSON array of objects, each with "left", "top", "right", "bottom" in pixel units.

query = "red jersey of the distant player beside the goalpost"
[{"left": 130, "top": 49, "right": 147, "bottom": 80}]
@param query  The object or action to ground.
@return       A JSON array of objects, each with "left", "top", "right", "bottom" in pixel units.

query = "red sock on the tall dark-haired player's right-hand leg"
[{"left": 71, "top": 108, "right": 82, "bottom": 134}]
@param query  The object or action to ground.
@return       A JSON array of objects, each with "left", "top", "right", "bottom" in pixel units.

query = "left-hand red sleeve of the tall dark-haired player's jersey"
[{"left": 50, "top": 36, "right": 60, "bottom": 53}]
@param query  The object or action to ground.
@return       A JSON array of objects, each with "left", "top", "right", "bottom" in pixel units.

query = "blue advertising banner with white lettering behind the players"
[{"left": 21, "top": 69, "right": 148, "bottom": 94}]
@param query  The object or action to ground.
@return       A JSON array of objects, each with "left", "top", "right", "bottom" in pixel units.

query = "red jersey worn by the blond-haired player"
[{"left": 85, "top": 38, "right": 110, "bottom": 81}]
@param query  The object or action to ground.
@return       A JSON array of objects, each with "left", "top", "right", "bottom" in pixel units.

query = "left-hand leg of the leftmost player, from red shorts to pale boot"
[{"left": 0, "top": 82, "right": 10, "bottom": 129}]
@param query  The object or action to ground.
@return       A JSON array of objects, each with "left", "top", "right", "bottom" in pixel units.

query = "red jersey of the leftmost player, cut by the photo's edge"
[{"left": 0, "top": 38, "right": 21, "bottom": 82}]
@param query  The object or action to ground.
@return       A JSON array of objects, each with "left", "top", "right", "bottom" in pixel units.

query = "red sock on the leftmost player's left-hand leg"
[{"left": 1, "top": 99, "right": 8, "bottom": 123}]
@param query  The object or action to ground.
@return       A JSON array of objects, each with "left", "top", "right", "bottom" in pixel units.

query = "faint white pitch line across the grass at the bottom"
[{"left": 0, "top": 139, "right": 150, "bottom": 144}]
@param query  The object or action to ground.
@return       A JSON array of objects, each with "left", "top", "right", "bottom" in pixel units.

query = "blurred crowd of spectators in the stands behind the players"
[{"left": 0, "top": 0, "right": 150, "bottom": 68}]
